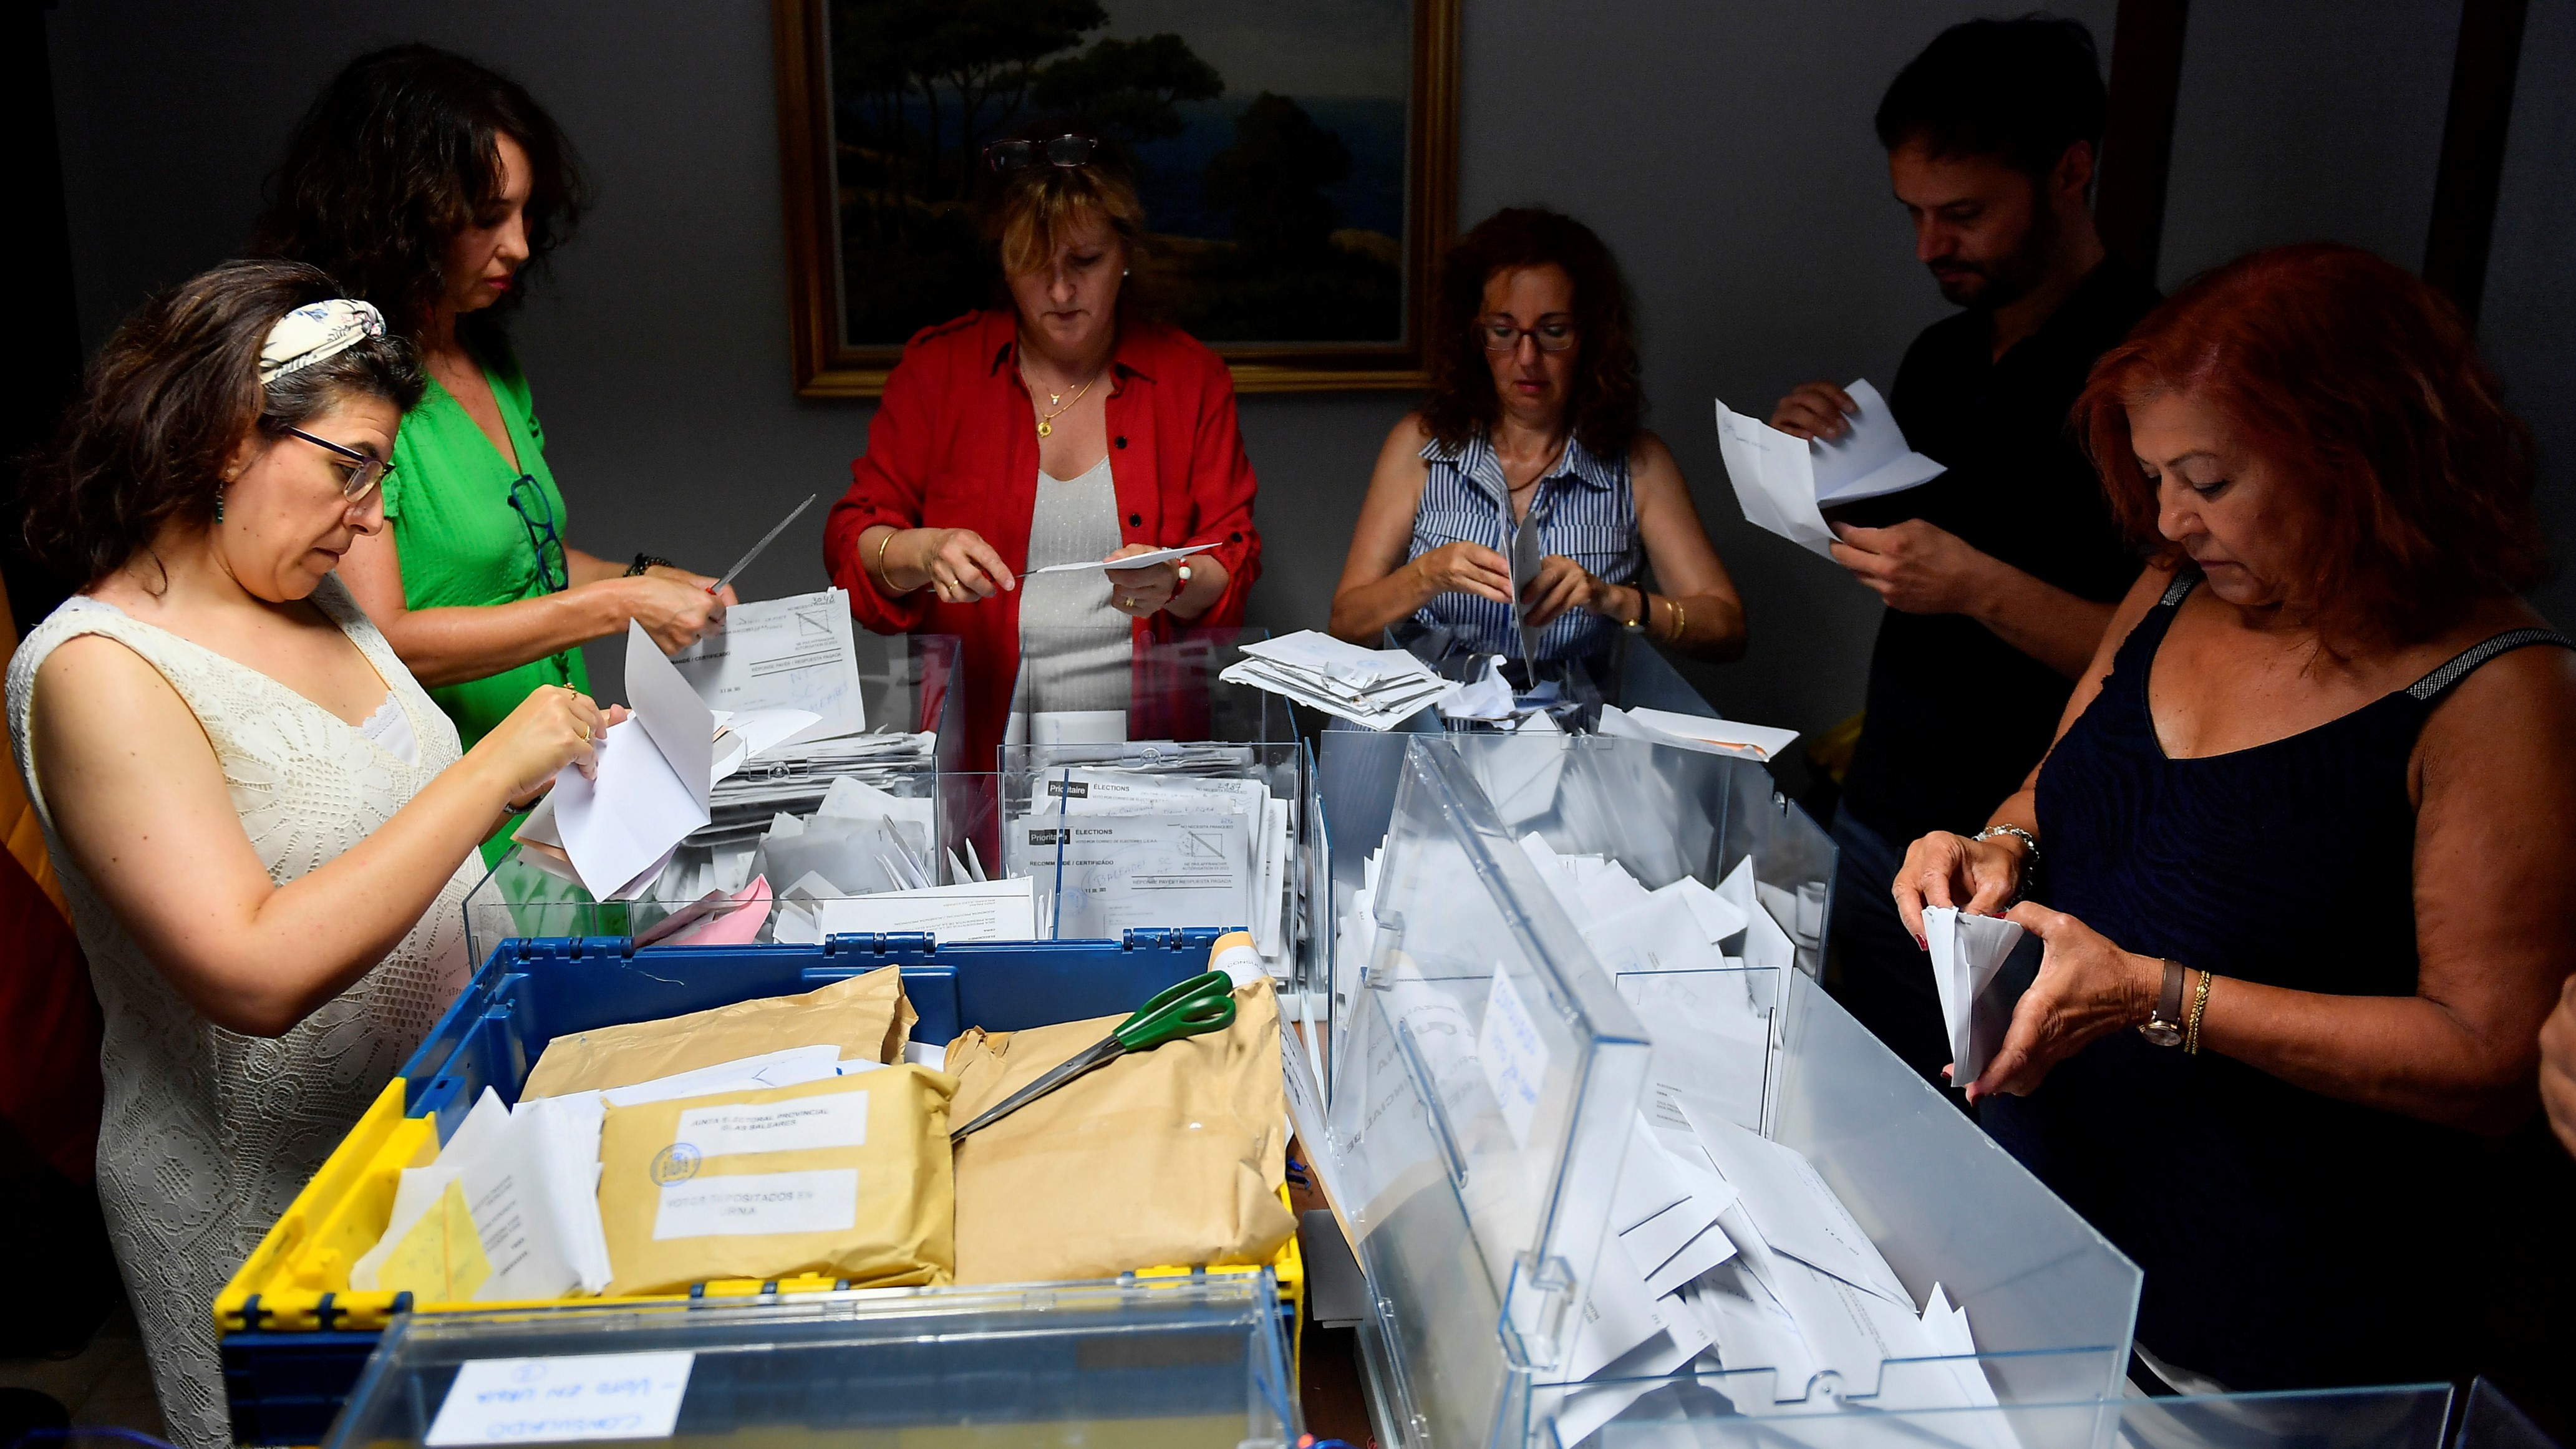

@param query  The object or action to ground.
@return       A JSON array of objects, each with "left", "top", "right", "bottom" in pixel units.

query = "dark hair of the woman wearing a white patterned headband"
[{"left": 23, "top": 260, "right": 422, "bottom": 583}]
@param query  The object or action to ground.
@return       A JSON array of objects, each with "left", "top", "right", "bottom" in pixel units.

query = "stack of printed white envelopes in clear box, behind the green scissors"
[{"left": 1002, "top": 763, "right": 1295, "bottom": 974}]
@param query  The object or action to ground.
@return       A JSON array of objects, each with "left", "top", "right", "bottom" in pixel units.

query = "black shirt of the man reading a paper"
[{"left": 1831, "top": 260, "right": 2159, "bottom": 851}]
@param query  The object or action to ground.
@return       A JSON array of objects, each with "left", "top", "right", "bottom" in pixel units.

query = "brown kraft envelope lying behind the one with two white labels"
[{"left": 518, "top": 967, "right": 919, "bottom": 1098}]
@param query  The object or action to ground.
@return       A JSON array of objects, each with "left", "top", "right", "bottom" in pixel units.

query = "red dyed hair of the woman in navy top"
[{"left": 2074, "top": 243, "right": 2542, "bottom": 652}]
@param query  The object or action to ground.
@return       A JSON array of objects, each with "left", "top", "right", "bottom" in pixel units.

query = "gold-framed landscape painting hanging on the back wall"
[{"left": 775, "top": 0, "right": 1458, "bottom": 397}]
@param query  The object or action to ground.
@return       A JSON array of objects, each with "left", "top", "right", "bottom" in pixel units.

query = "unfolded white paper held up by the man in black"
[{"left": 1718, "top": 382, "right": 1945, "bottom": 557}]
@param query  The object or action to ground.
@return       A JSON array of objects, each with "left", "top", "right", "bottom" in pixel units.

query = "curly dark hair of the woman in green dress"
[{"left": 250, "top": 44, "right": 588, "bottom": 356}]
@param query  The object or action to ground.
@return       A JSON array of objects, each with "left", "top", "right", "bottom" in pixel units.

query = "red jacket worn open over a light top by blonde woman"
[{"left": 821, "top": 312, "right": 1262, "bottom": 771}]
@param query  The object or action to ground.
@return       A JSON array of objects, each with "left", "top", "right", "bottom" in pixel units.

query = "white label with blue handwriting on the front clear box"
[{"left": 425, "top": 1351, "right": 698, "bottom": 1449}]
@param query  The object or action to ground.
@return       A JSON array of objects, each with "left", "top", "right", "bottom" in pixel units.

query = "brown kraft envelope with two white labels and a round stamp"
[{"left": 600, "top": 1067, "right": 956, "bottom": 1297}]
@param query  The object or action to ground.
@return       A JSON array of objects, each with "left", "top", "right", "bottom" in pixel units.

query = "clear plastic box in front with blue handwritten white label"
[{"left": 322, "top": 1279, "right": 1301, "bottom": 1449}]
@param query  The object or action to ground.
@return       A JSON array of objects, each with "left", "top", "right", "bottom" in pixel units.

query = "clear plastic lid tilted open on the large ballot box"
[{"left": 1309, "top": 737, "right": 1649, "bottom": 1444}]
